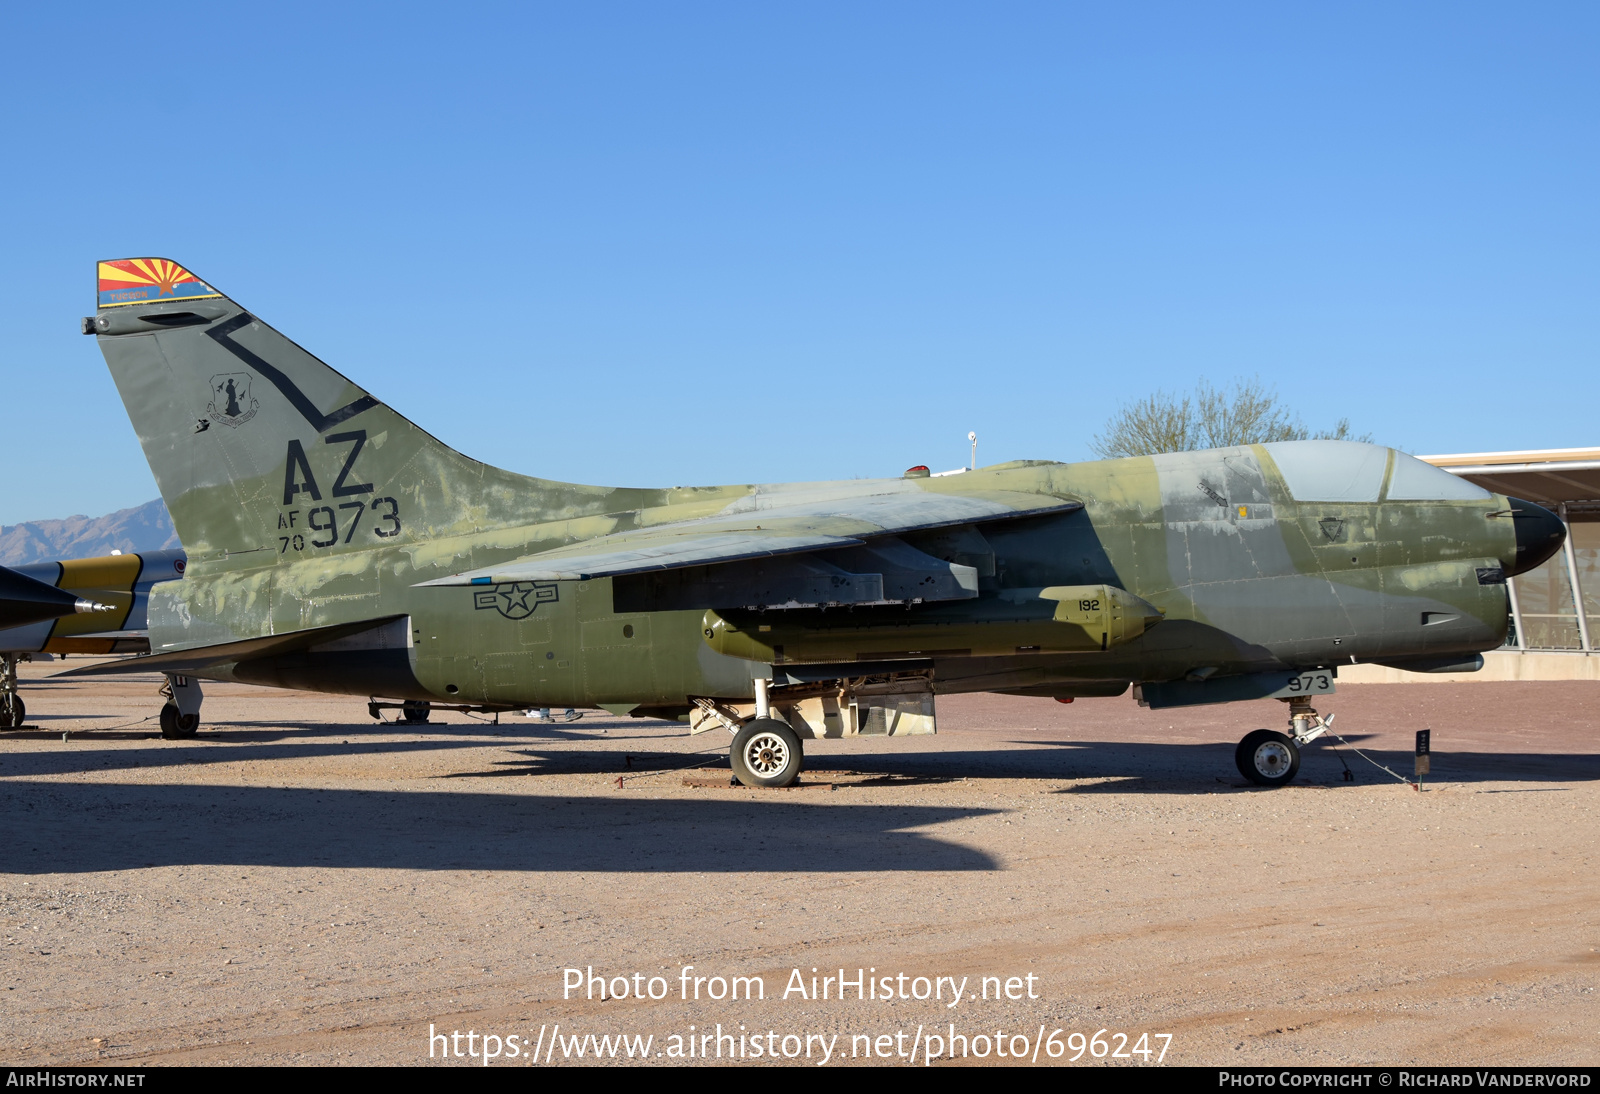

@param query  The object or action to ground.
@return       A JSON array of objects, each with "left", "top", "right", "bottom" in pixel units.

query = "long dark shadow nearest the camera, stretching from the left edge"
[{"left": 0, "top": 781, "right": 998, "bottom": 875}]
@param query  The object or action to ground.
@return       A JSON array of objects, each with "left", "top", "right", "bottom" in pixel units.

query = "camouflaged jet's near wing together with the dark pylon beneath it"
[{"left": 421, "top": 486, "right": 1083, "bottom": 609}]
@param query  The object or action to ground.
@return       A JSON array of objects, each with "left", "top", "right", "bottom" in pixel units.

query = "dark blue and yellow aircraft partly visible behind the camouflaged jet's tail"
[{"left": 0, "top": 550, "right": 184, "bottom": 729}]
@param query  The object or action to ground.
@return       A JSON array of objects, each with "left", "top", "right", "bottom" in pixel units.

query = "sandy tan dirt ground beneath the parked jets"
[{"left": 0, "top": 664, "right": 1600, "bottom": 1067}]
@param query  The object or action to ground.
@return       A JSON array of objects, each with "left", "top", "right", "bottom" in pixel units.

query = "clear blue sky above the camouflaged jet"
[{"left": 0, "top": 3, "right": 1600, "bottom": 523}]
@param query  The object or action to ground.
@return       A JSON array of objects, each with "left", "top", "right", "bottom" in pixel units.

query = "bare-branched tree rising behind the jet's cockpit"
[{"left": 1090, "top": 376, "right": 1373, "bottom": 459}]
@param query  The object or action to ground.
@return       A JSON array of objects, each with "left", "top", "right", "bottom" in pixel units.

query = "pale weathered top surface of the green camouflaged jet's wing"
[{"left": 421, "top": 489, "right": 1083, "bottom": 585}]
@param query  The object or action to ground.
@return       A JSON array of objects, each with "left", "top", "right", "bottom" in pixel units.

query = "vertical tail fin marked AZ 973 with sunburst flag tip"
[{"left": 85, "top": 259, "right": 616, "bottom": 563}]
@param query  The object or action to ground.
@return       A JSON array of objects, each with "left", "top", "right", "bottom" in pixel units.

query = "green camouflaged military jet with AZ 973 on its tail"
[{"left": 62, "top": 259, "right": 1563, "bottom": 787}]
